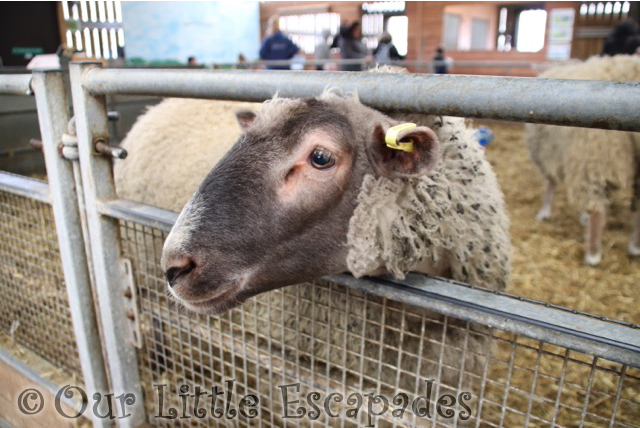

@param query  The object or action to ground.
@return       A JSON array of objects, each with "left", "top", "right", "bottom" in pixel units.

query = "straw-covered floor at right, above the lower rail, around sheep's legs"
[{"left": 476, "top": 121, "right": 640, "bottom": 324}]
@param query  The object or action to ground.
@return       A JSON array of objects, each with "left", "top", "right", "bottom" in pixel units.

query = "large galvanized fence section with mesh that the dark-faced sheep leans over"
[{"left": 0, "top": 63, "right": 640, "bottom": 427}]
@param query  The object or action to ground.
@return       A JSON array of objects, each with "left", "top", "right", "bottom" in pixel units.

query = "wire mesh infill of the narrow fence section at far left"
[{"left": 0, "top": 186, "right": 82, "bottom": 379}]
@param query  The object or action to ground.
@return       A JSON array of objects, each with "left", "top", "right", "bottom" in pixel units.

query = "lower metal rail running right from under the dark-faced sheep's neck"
[{"left": 325, "top": 274, "right": 640, "bottom": 367}]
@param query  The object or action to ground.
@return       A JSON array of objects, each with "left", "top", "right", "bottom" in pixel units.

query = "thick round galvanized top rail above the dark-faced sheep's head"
[{"left": 83, "top": 68, "right": 640, "bottom": 131}]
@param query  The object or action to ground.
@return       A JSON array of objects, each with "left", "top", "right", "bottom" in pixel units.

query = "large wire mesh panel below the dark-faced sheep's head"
[{"left": 120, "top": 221, "right": 640, "bottom": 427}]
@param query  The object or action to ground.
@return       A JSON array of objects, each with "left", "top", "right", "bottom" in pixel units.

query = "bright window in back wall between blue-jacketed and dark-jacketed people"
[{"left": 279, "top": 12, "right": 340, "bottom": 54}]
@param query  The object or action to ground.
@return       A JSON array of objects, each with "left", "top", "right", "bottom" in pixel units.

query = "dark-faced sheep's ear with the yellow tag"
[{"left": 369, "top": 125, "right": 440, "bottom": 178}]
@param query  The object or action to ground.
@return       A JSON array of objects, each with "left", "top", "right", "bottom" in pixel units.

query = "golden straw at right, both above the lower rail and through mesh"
[{"left": 486, "top": 122, "right": 640, "bottom": 426}]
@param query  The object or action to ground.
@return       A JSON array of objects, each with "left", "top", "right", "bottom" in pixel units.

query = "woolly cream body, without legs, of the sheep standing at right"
[{"left": 525, "top": 55, "right": 640, "bottom": 211}]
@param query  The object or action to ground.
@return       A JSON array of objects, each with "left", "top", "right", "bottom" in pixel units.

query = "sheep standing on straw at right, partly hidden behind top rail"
[{"left": 525, "top": 55, "right": 640, "bottom": 266}]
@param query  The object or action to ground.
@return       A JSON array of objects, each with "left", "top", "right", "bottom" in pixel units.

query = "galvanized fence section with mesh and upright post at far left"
[{"left": 0, "top": 72, "right": 110, "bottom": 426}]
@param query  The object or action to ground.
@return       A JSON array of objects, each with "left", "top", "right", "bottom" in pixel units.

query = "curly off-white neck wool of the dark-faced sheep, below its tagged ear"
[{"left": 347, "top": 115, "right": 511, "bottom": 289}]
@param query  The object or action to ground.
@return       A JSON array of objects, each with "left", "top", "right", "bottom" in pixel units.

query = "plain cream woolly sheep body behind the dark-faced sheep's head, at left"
[{"left": 114, "top": 98, "right": 259, "bottom": 211}]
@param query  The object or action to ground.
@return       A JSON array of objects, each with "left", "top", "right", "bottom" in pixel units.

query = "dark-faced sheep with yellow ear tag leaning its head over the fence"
[{"left": 163, "top": 93, "right": 509, "bottom": 300}]
